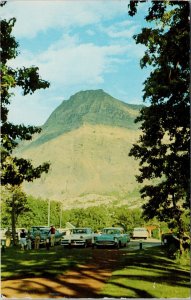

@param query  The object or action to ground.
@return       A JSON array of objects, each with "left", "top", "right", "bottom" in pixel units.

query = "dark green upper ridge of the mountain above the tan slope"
[{"left": 26, "top": 89, "right": 142, "bottom": 147}]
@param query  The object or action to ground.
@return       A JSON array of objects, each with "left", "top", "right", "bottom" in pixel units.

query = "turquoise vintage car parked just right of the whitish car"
[{"left": 93, "top": 227, "right": 130, "bottom": 248}]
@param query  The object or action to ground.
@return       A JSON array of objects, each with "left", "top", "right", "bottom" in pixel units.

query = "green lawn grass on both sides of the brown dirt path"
[{"left": 1, "top": 246, "right": 190, "bottom": 299}]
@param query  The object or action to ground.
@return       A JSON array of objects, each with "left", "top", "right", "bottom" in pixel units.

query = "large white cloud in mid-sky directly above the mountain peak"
[{"left": 9, "top": 35, "right": 128, "bottom": 88}]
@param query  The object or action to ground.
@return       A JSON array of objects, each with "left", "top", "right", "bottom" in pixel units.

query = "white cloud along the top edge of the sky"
[{"left": 3, "top": 0, "right": 127, "bottom": 38}]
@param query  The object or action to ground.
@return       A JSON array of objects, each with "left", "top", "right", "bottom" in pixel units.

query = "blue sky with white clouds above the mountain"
[{"left": 2, "top": 0, "right": 149, "bottom": 125}]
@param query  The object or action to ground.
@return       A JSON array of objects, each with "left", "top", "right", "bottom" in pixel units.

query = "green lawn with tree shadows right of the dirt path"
[{"left": 101, "top": 247, "right": 190, "bottom": 299}]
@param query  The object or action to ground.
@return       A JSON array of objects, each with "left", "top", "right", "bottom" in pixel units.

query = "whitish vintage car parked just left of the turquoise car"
[{"left": 61, "top": 227, "right": 93, "bottom": 248}]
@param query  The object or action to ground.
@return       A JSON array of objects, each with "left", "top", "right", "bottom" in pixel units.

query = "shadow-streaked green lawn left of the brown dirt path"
[{"left": 1, "top": 246, "right": 91, "bottom": 280}]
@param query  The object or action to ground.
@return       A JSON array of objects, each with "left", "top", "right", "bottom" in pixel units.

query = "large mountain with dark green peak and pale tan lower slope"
[{"left": 17, "top": 90, "right": 141, "bottom": 208}]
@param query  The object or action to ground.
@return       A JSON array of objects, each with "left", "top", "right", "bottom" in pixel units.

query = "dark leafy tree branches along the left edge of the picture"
[{"left": 0, "top": 8, "right": 49, "bottom": 186}]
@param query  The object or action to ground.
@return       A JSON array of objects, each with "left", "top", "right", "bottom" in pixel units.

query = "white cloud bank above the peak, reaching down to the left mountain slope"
[{"left": 6, "top": 35, "right": 133, "bottom": 125}]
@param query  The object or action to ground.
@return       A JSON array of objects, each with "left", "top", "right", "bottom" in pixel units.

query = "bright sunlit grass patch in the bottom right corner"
[{"left": 102, "top": 268, "right": 190, "bottom": 298}]
